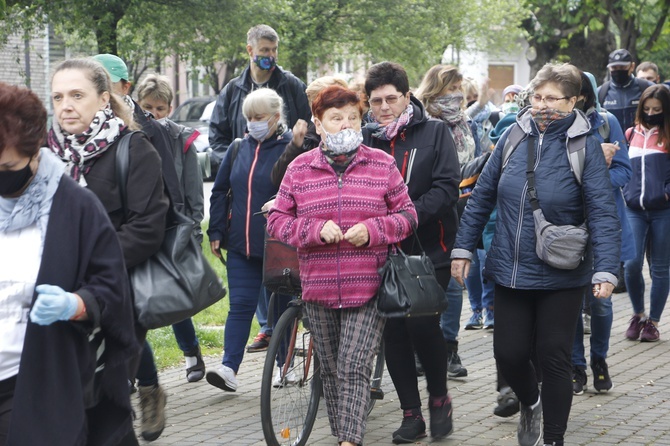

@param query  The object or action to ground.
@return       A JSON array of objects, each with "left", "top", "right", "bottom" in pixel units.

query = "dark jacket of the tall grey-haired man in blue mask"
[{"left": 209, "top": 67, "right": 312, "bottom": 164}]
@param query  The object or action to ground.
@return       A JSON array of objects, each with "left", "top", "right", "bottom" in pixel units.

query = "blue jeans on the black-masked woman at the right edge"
[{"left": 624, "top": 208, "right": 670, "bottom": 322}]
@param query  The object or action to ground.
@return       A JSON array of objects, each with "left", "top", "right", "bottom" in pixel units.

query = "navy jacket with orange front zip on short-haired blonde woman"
[{"left": 207, "top": 130, "right": 293, "bottom": 259}]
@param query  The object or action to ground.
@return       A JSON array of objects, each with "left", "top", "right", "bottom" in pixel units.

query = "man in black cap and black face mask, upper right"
[{"left": 598, "top": 49, "right": 654, "bottom": 131}]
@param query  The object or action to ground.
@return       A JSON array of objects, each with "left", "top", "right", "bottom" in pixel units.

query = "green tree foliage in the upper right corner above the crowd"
[{"left": 523, "top": 0, "right": 670, "bottom": 79}]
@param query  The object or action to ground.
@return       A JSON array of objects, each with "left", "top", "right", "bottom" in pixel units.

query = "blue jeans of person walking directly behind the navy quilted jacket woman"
[{"left": 572, "top": 286, "right": 613, "bottom": 369}]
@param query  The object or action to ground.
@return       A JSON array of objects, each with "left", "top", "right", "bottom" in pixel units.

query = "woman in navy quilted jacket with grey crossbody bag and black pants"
[{"left": 451, "top": 64, "right": 620, "bottom": 445}]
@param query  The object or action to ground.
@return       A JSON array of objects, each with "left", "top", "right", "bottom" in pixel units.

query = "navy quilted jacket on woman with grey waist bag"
[{"left": 452, "top": 110, "right": 621, "bottom": 290}]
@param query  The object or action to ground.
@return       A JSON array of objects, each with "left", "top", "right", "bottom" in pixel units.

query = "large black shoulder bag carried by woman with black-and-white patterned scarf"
[{"left": 116, "top": 134, "right": 226, "bottom": 329}]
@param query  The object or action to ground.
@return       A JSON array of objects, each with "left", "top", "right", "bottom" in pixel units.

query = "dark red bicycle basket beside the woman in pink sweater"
[{"left": 263, "top": 230, "right": 302, "bottom": 296}]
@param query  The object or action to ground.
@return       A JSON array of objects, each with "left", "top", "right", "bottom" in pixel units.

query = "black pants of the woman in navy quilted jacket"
[{"left": 493, "top": 285, "right": 584, "bottom": 443}]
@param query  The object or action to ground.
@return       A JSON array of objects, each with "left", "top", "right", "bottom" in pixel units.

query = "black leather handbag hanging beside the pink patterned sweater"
[{"left": 377, "top": 228, "right": 447, "bottom": 317}]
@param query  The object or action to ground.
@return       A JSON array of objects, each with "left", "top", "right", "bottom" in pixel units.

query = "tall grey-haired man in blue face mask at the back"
[{"left": 209, "top": 25, "right": 312, "bottom": 174}]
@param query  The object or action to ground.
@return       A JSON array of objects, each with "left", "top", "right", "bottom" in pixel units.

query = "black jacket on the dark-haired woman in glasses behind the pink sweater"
[{"left": 363, "top": 96, "right": 461, "bottom": 268}]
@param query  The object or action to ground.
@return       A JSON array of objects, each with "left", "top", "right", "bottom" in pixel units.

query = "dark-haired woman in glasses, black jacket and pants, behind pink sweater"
[{"left": 363, "top": 62, "right": 462, "bottom": 444}]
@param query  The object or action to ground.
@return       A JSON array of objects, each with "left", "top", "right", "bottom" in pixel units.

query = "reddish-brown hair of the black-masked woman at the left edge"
[{"left": 0, "top": 82, "right": 47, "bottom": 157}]
